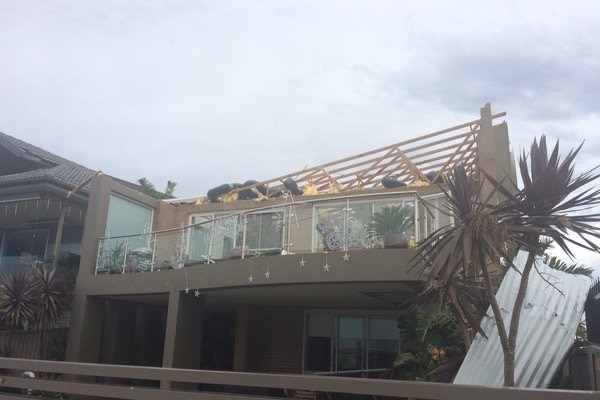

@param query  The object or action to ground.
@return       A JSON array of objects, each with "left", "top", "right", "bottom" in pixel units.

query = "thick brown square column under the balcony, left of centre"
[{"left": 160, "top": 291, "right": 205, "bottom": 389}]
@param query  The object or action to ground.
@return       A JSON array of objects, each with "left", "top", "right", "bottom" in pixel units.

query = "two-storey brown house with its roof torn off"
[{"left": 67, "top": 104, "right": 514, "bottom": 388}]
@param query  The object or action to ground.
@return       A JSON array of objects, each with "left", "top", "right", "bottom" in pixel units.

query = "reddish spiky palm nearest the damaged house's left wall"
[{"left": 32, "top": 268, "right": 68, "bottom": 359}]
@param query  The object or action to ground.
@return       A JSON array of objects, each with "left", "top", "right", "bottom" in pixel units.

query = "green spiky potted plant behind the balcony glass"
[{"left": 372, "top": 205, "right": 414, "bottom": 249}]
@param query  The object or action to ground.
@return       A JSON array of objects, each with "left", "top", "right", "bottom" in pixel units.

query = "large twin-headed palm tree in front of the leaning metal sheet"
[{"left": 413, "top": 136, "right": 600, "bottom": 386}]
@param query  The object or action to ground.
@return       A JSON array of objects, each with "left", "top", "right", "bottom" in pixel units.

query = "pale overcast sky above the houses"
[{"left": 0, "top": 0, "right": 600, "bottom": 266}]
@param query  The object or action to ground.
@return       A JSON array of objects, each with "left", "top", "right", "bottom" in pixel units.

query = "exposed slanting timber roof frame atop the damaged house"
[{"left": 225, "top": 108, "right": 506, "bottom": 195}]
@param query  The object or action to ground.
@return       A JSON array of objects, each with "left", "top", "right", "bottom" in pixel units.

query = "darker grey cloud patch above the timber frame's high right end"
[{"left": 385, "top": 39, "right": 600, "bottom": 119}]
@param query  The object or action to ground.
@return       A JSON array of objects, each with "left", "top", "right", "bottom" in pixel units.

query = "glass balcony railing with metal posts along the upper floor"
[{"left": 96, "top": 194, "right": 450, "bottom": 274}]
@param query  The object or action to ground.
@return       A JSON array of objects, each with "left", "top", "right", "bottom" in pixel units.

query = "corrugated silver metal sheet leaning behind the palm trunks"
[{"left": 454, "top": 252, "right": 591, "bottom": 388}]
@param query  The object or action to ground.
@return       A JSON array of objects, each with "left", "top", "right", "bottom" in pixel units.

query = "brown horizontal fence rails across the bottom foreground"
[{"left": 0, "top": 358, "right": 600, "bottom": 400}]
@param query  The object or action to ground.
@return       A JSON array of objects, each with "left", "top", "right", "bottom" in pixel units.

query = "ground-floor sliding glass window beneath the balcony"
[{"left": 304, "top": 312, "right": 400, "bottom": 373}]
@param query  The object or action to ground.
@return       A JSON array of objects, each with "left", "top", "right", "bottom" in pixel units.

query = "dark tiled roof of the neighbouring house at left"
[{"left": 0, "top": 132, "right": 95, "bottom": 193}]
